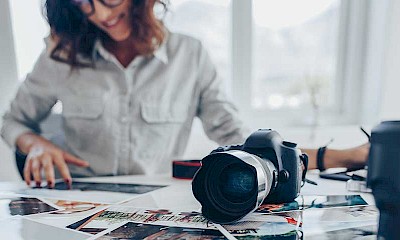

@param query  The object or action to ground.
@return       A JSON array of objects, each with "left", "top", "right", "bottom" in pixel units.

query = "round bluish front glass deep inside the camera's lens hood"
[{"left": 219, "top": 163, "right": 257, "bottom": 203}]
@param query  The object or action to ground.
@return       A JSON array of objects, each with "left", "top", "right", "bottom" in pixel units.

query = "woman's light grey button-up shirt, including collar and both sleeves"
[{"left": 1, "top": 33, "right": 247, "bottom": 176}]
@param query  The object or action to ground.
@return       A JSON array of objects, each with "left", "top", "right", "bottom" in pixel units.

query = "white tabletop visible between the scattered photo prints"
[{"left": 0, "top": 171, "right": 374, "bottom": 240}]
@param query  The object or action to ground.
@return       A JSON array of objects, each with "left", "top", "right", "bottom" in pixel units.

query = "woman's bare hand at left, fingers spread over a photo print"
[{"left": 17, "top": 133, "right": 89, "bottom": 188}]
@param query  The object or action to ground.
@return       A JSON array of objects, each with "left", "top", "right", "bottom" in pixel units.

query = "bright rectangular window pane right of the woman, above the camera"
[{"left": 251, "top": 0, "right": 340, "bottom": 110}]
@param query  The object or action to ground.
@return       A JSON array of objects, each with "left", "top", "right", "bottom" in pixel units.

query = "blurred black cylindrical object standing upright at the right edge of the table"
[{"left": 367, "top": 121, "right": 400, "bottom": 240}]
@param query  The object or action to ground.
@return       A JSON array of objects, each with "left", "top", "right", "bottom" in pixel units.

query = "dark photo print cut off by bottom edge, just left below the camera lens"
[{"left": 98, "top": 222, "right": 227, "bottom": 240}]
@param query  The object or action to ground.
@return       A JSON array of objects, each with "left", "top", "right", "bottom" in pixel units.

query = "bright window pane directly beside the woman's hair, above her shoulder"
[{"left": 165, "top": 0, "right": 231, "bottom": 90}]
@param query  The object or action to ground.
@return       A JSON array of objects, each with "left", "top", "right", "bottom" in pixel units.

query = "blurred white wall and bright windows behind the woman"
[{"left": 0, "top": 0, "right": 400, "bottom": 180}]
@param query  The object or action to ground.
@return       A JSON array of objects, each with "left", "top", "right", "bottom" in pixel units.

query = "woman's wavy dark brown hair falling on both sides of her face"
[{"left": 45, "top": 0, "right": 167, "bottom": 67}]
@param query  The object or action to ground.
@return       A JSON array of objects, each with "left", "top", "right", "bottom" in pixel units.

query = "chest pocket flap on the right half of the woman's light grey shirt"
[{"left": 141, "top": 103, "right": 187, "bottom": 124}]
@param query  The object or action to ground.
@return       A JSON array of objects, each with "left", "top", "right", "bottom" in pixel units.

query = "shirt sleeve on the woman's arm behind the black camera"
[{"left": 197, "top": 44, "right": 249, "bottom": 145}]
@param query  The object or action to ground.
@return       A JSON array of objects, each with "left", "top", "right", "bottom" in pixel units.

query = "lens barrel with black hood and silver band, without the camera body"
[{"left": 192, "top": 150, "right": 276, "bottom": 223}]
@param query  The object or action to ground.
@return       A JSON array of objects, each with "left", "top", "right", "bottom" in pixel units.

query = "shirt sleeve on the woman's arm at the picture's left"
[{"left": 1, "top": 50, "right": 60, "bottom": 147}]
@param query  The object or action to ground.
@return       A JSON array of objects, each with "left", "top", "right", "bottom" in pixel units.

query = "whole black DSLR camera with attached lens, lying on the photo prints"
[{"left": 192, "top": 129, "right": 308, "bottom": 224}]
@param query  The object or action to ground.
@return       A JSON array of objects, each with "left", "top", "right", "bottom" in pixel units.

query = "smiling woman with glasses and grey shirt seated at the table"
[{"left": 2, "top": 0, "right": 363, "bottom": 187}]
